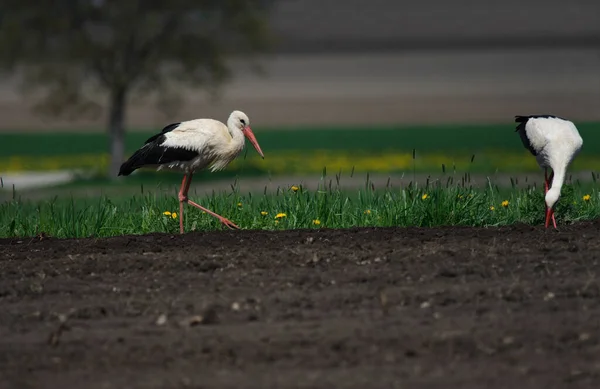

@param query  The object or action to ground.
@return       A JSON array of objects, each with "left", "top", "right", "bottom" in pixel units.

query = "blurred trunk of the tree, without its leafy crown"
[{"left": 108, "top": 88, "right": 126, "bottom": 179}]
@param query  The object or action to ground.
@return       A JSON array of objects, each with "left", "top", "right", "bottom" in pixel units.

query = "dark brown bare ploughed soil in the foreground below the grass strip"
[{"left": 0, "top": 222, "right": 600, "bottom": 389}]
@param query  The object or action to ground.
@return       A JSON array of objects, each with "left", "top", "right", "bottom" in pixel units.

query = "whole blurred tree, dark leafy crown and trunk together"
[{"left": 0, "top": 0, "right": 274, "bottom": 179}]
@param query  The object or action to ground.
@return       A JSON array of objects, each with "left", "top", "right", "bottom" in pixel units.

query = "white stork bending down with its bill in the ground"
[{"left": 515, "top": 115, "right": 583, "bottom": 228}]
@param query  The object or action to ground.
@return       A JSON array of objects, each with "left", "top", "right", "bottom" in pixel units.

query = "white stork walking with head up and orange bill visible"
[{"left": 119, "top": 111, "right": 265, "bottom": 234}]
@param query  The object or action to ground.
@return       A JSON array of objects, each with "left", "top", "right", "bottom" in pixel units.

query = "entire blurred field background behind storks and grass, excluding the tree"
[{"left": 0, "top": 0, "right": 600, "bottom": 200}]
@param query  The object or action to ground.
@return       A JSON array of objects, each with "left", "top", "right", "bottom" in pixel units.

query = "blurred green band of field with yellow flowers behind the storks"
[{"left": 0, "top": 123, "right": 600, "bottom": 175}]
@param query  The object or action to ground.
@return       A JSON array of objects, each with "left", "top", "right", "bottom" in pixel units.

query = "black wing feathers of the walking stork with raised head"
[{"left": 119, "top": 123, "right": 199, "bottom": 176}]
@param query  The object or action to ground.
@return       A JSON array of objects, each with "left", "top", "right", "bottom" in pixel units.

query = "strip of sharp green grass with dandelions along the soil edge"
[{"left": 0, "top": 170, "right": 600, "bottom": 238}]
